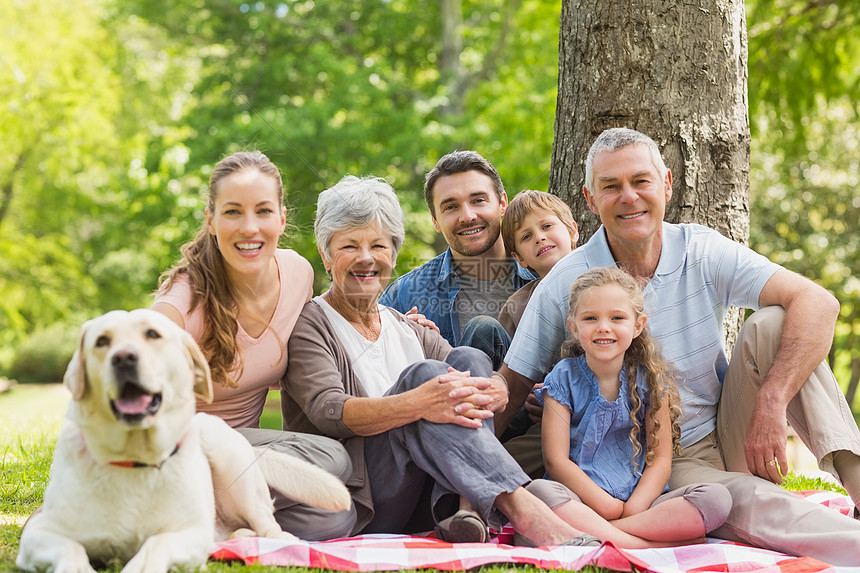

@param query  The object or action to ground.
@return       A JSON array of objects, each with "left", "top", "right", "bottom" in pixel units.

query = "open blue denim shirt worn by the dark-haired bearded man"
[{"left": 379, "top": 247, "right": 537, "bottom": 346}]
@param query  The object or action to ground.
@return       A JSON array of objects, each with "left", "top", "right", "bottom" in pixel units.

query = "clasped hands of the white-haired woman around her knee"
[{"left": 415, "top": 368, "right": 493, "bottom": 429}]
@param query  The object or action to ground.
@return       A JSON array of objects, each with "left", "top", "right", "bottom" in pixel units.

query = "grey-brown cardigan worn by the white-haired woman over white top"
[{"left": 281, "top": 301, "right": 451, "bottom": 533}]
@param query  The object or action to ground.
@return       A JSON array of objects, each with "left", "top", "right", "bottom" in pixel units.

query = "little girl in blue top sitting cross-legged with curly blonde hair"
[{"left": 535, "top": 267, "right": 731, "bottom": 544}]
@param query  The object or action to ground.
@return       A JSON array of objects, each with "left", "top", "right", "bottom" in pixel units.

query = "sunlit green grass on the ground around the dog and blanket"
[{"left": 0, "top": 384, "right": 844, "bottom": 573}]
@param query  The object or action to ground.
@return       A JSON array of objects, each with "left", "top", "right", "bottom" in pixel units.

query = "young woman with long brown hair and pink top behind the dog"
[{"left": 153, "top": 151, "right": 355, "bottom": 540}]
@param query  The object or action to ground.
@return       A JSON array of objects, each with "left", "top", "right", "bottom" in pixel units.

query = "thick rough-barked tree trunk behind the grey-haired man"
[{"left": 549, "top": 0, "right": 750, "bottom": 349}]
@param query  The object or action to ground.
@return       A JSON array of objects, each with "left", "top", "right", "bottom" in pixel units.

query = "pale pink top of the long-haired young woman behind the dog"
[{"left": 155, "top": 249, "right": 314, "bottom": 428}]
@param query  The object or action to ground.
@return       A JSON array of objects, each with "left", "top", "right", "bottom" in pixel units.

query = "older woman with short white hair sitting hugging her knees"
[{"left": 281, "top": 176, "right": 672, "bottom": 547}]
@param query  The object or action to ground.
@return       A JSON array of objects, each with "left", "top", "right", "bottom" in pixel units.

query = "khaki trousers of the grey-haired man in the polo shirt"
[{"left": 669, "top": 307, "right": 860, "bottom": 565}]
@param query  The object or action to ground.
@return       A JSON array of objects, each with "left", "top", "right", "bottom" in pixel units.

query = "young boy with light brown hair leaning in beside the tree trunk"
[{"left": 499, "top": 189, "right": 579, "bottom": 338}]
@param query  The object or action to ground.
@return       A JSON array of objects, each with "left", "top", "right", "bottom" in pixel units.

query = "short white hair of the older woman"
[{"left": 314, "top": 175, "right": 406, "bottom": 262}]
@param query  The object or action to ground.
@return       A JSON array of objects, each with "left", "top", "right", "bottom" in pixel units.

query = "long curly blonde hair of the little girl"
[{"left": 561, "top": 267, "right": 681, "bottom": 470}]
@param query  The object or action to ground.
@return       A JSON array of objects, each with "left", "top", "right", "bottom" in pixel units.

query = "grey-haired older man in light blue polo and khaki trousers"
[{"left": 497, "top": 129, "right": 860, "bottom": 565}]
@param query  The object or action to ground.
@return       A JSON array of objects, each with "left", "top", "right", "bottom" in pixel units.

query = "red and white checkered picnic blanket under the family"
[{"left": 211, "top": 492, "right": 860, "bottom": 573}]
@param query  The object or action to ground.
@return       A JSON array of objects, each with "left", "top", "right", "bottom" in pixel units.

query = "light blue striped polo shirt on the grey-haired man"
[{"left": 505, "top": 222, "right": 781, "bottom": 447}]
